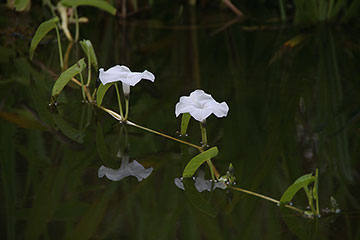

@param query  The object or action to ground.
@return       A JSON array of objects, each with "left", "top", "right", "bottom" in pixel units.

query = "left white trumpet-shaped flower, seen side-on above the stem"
[{"left": 99, "top": 65, "right": 155, "bottom": 95}]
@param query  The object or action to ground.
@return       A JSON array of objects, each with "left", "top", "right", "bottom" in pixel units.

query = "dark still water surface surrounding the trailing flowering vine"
[{"left": 0, "top": 6, "right": 360, "bottom": 239}]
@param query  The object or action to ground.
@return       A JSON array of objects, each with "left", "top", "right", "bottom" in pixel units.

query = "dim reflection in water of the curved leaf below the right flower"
[{"left": 183, "top": 179, "right": 217, "bottom": 217}]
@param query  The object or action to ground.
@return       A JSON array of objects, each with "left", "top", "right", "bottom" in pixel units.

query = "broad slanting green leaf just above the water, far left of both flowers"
[{"left": 51, "top": 58, "right": 86, "bottom": 97}]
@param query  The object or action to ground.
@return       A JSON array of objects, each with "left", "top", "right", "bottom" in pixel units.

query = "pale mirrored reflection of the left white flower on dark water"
[{"left": 98, "top": 156, "right": 153, "bottom": 182}]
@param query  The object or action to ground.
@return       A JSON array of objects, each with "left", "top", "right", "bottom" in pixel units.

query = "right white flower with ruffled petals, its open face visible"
[{"left": 175, "top": 90, "right": 229, "bottom": 122}]
